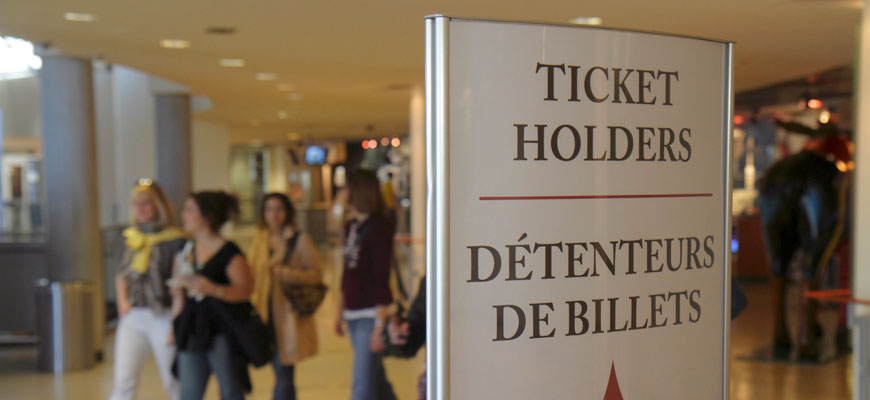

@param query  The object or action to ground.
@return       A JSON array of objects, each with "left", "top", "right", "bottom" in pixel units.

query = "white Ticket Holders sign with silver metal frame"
[{"left": 427, "top": 17, "right": 731, "bottom": 400}]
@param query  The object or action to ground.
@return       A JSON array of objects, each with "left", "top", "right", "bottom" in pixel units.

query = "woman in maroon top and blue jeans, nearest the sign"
[{"left": 335, "top": 170, "right": 396, "bottom": 400}]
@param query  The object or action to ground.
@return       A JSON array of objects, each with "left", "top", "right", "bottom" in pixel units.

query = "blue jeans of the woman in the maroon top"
[{"left": 347, "top": 318, "right": 396, "bottom": 400}]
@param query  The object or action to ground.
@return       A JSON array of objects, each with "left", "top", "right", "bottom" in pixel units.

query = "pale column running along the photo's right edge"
[{"left": 852, "top": 0, "right": 870, "bottom": 400}]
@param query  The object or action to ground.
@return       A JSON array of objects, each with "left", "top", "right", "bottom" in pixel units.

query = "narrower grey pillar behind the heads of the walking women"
[{"left": 155, "top": 94, "right": 192, "bottom": 213}]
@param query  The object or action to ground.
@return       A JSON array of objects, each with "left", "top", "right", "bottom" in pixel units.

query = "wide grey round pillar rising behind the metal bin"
[{"left": 40, "top": 55, "right": 105, "bottom": 360}]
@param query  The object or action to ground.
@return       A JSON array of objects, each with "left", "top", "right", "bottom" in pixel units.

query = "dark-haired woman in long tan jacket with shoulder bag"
[{"left": 250, "top": 193, "right": 323, "bottom": 400}]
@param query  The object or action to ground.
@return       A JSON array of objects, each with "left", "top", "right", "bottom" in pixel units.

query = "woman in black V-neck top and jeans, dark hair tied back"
[{"left": 173, "top": 192, "right": 253, "bottom": 400}]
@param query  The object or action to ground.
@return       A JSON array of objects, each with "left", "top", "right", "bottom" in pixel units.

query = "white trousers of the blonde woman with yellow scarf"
[{"left": 111, "top": 307, "right": 180, "bottom": 400}]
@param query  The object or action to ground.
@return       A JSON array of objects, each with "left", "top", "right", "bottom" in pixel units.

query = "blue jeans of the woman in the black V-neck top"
[{"left": 178, "top": 335, "right": 245, "bottom": 400}]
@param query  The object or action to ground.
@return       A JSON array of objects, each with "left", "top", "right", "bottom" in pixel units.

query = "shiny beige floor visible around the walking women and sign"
[{"left": 0, "top": 262, "right": 851, "bottom": 400}]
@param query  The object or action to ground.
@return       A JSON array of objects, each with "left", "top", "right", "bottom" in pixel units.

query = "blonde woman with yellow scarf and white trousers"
[{"left": 111, "top": 179, "right": 184, "bottom": 400}]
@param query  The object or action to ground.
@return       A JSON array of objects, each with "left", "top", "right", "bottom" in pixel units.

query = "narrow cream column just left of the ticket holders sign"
[{"left": 408, "top": 87, "right": 426, "bottom": 276}]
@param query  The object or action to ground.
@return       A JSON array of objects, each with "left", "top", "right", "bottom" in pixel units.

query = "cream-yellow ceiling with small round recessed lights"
[{"left": 0, "top": 0, "right": 862, "bottom": 139}]
